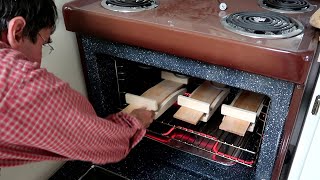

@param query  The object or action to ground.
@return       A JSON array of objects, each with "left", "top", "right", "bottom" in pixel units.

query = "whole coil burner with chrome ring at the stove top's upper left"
[{"left": 101, "top": 0, "right": 158, "bottom": 12}]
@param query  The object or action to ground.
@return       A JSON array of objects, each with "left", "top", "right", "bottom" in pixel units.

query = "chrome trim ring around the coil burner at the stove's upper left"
[{"left": 101, "top": 0, "right": 158, "bottom": 13}]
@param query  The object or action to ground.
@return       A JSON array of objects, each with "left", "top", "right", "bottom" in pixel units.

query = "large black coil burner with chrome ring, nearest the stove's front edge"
[{"left": 221, "top": 12, "right": 304, "bottom": 39}]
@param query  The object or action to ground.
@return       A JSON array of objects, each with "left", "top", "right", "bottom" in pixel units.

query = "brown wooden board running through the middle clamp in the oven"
[{"left": 173, "top": 81, "right": 222, "bottom": 124}]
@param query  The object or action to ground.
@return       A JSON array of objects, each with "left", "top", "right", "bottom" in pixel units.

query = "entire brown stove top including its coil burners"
[{"left": 64, "top": 0, "right": 320, "bottom": 83}]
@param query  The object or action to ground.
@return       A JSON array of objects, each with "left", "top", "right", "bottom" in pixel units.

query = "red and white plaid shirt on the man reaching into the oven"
[{"left": 0, "top": 42, "right": 145, "bottom": 167}]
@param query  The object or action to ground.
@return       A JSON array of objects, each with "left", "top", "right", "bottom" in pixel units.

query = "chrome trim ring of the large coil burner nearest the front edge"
[{"left": 221, "top": 14, "right": 304, "bottom": 39}]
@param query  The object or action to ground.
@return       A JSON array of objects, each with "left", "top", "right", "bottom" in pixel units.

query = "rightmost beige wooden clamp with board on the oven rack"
[{"left": 219, "top": 91, "right": 265, "bottom": 136}]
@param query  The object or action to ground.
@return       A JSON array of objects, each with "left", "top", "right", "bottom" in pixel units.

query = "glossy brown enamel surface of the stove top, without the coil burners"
[{"left": 63, "top": 0, "right": 320, "bottom": 83}]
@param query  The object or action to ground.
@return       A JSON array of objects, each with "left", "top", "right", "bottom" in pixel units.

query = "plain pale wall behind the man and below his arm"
[{"left": 0, "top": 0, "right": 86, "bottom": 180}]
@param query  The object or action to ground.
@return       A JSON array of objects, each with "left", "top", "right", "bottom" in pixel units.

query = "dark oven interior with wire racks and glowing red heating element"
[{"left": 115, "top": 61, "right": 270, "bottom": 167}]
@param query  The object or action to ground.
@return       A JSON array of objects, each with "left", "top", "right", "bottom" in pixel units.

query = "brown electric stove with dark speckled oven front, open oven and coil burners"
[{"left": 63, "top": 0, "right": 320, "bottom": 179}]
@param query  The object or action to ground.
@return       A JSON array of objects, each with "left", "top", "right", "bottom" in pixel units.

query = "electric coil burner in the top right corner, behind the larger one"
[{"left": 259, "top": 0, "right": 314, "bottom": 13}]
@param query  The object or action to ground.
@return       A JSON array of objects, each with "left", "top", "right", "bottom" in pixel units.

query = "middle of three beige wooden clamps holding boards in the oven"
[{"left": 173, "top": 81, "right": 230, "bottom": 125}]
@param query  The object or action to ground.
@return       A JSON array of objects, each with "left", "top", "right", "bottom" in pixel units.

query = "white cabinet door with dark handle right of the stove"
[{"left": 288, "top": 65, "right": 320, "bottom": 180}]
